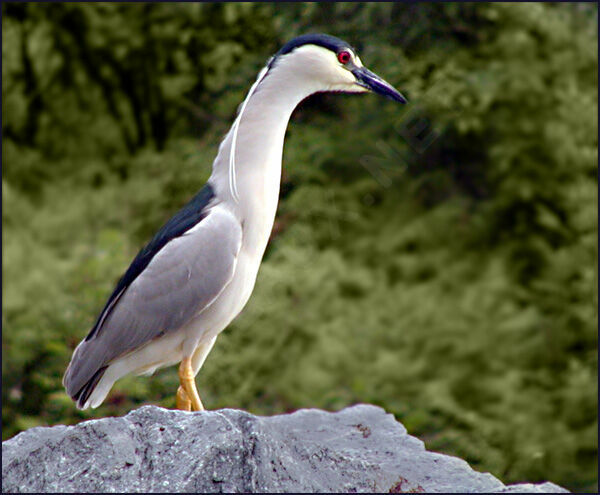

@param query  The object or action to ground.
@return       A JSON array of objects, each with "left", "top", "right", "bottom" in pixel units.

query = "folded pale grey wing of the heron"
[{"left": 65, "top": 207, "right": 242, "bottom": 393}]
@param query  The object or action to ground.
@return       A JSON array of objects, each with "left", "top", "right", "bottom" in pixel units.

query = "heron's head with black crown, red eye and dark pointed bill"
[{"left": 268, "top": 34, "right": 406, "bottom": 103}]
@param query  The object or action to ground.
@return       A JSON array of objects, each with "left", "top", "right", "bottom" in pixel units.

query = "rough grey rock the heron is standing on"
[{"left": 2, "top": 405, "right": 566, "bottom": 493}]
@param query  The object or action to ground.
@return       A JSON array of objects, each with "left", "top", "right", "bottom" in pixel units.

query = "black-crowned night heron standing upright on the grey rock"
[{"left": 63, "top": 34, "right": 406, "bottom": 411}]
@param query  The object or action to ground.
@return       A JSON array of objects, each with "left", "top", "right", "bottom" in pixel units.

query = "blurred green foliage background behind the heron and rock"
[{"left": 2, "top": 3, "right": 598, "bottom": 491}]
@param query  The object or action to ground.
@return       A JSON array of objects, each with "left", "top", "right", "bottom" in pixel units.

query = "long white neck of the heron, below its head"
[{"left": 209, "top": 56, "right": 320, "bottom": 258}]
